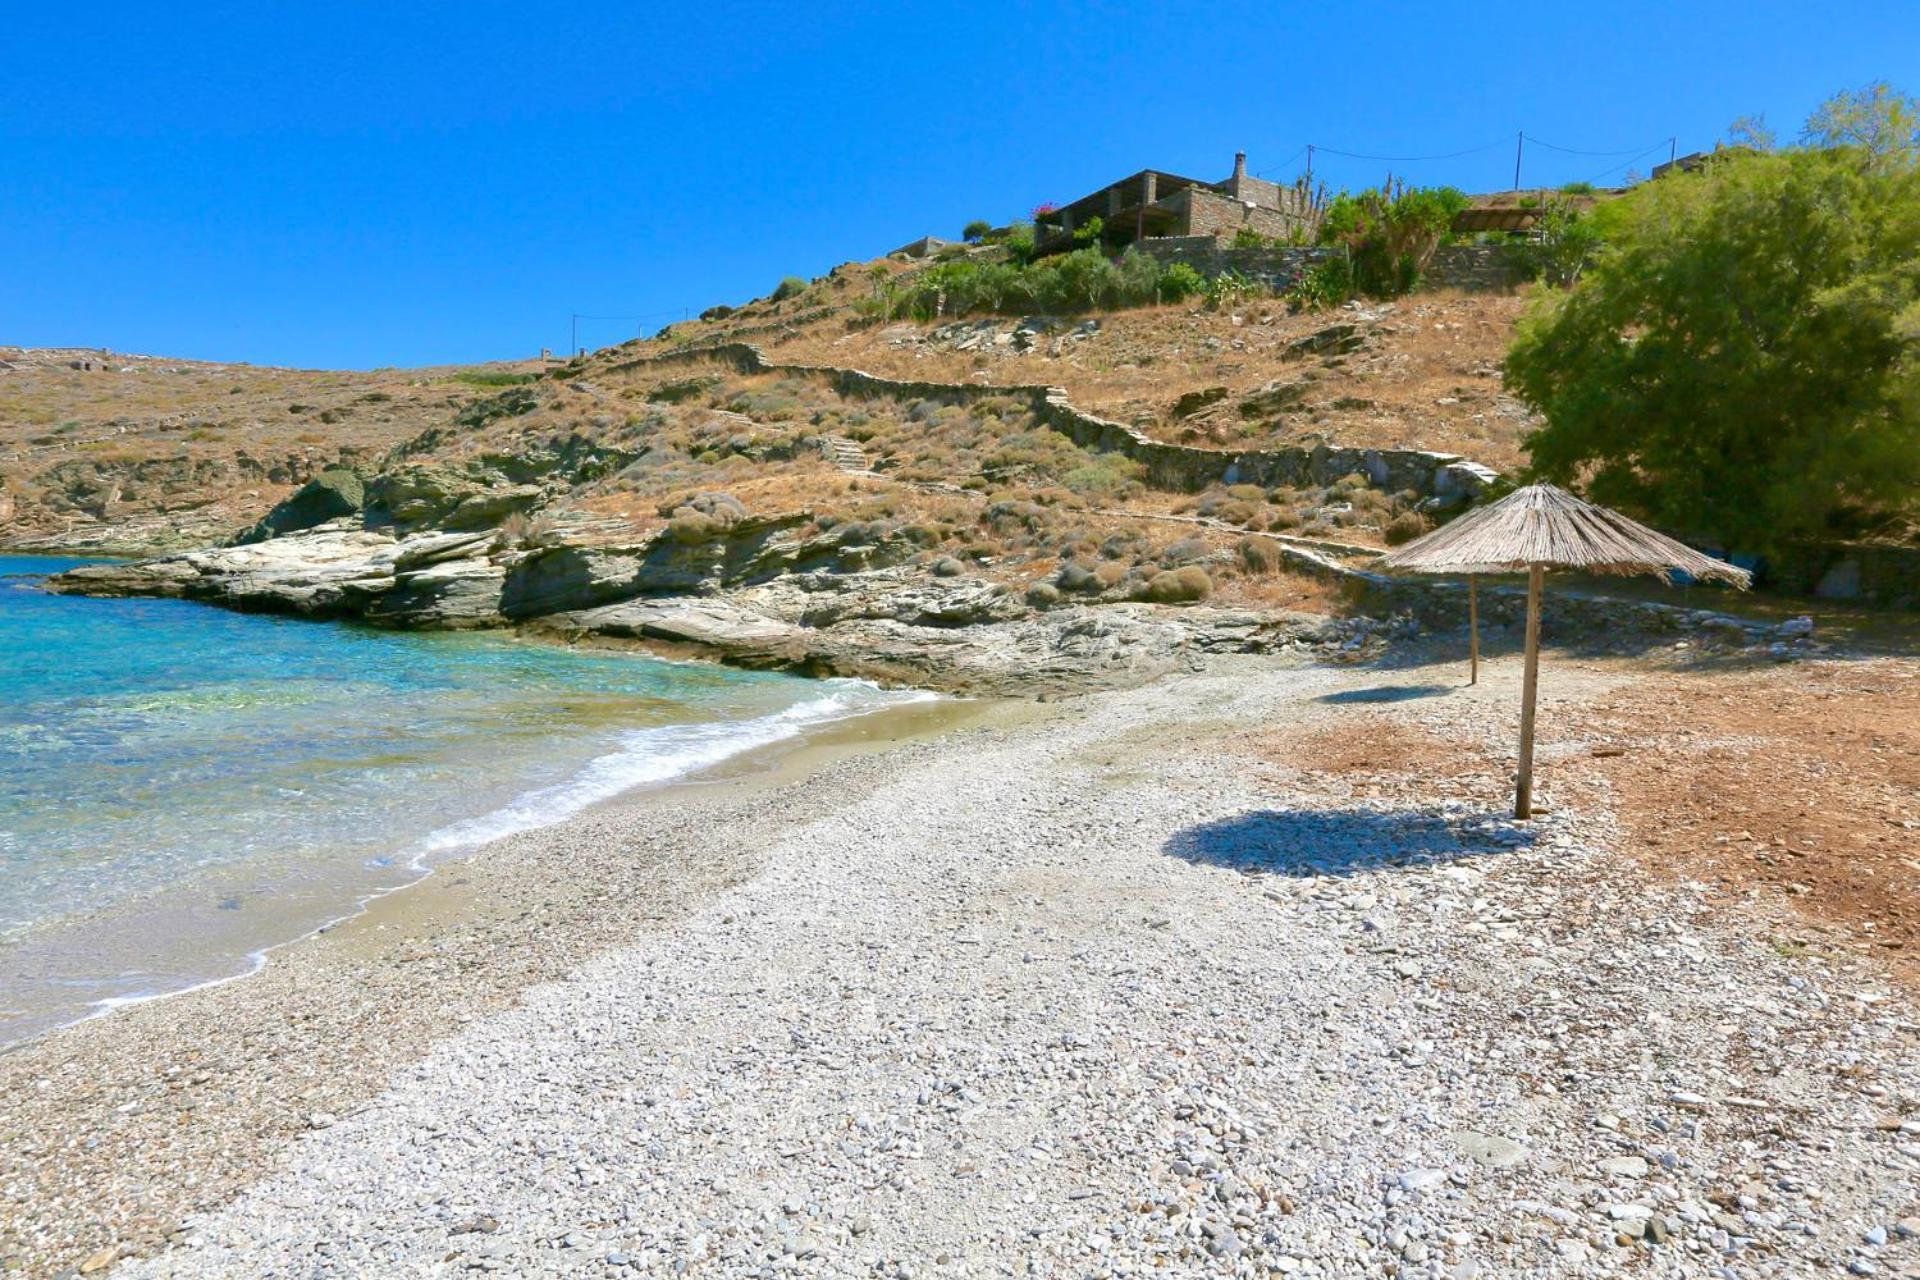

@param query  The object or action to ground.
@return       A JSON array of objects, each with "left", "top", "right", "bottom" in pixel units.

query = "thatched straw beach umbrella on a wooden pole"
[{"left": 1375, "top": 484, "right": 1751, "bottom": 818}]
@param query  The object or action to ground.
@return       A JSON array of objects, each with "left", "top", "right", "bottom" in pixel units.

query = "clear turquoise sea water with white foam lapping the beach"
[{"left": 0, "top": 557, "right": 929, "bottom": 1044}]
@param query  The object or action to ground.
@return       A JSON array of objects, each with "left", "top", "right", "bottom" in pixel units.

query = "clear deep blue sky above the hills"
[{"left": 0, "top": 0, "right": 1920, "bottom": 368}]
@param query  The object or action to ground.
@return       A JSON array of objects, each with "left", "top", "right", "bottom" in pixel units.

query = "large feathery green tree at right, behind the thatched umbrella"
[{"left": 1505, "top": 86, "right": 1920, "bottom": 551}]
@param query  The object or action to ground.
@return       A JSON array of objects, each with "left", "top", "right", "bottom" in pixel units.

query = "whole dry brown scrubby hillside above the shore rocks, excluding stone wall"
[{"left": 0, "top": 261, "right": 1524, "bottom": 621}]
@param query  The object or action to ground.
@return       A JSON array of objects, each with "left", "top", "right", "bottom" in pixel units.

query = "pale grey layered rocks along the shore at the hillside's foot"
[{"left": 50, "top": 512, "right": 1350, "bottom": 691}]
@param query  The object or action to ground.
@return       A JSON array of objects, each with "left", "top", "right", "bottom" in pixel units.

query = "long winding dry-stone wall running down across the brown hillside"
[{"left": 616, "top": 342, "right": 1496, "bottom": 501}]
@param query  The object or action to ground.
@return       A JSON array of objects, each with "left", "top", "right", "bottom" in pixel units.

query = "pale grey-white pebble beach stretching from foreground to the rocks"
[{"left": 0, "top": 660, "right": 1920, "bottom": 1280}]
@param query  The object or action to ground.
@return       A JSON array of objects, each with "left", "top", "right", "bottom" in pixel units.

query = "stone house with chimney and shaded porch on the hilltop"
[{"left": 1035, "top": 152, "right": 1304, "bottom": 253}]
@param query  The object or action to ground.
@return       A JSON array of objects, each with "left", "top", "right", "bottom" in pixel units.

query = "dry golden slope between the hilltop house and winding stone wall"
[{"left": 668, "top": 276, "right": 1534, "bottom": 470}]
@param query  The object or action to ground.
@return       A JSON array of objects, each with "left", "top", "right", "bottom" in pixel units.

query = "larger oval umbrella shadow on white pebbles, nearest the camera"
[{"left": 1164, "top": 808, "right": 1534, "bottom": 879}]
